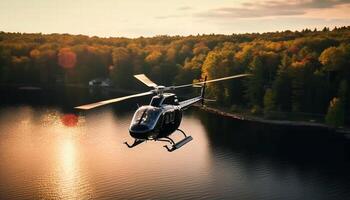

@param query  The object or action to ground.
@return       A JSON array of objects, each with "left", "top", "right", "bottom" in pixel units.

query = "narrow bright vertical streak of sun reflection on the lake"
[{"left": 34, "top": 108, "right": 91, "bottom": 199}]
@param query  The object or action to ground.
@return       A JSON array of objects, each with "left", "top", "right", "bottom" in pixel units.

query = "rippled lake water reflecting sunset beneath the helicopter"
[{"left": 0, "top": 86, "right": 350, "bottom": 200}]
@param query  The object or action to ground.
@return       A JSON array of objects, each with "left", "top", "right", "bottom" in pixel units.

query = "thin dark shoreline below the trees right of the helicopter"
[{"left": 195, "top": 105, "right": 350, "bottom": 135}]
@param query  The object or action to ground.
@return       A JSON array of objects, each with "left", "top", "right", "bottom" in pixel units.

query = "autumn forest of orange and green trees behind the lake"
[{"left": 0, "top": 27, "right": 350, "bottom": 126}]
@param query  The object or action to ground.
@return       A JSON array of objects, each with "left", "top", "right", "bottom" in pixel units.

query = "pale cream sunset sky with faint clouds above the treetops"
[{"left": 0, "top": 0, "right": 350, "bottom": 38}]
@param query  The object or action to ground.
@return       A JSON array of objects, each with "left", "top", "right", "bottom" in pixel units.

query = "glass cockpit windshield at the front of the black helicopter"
[{"left": 132, "top": 106, "right": 161, "bottom": 127}]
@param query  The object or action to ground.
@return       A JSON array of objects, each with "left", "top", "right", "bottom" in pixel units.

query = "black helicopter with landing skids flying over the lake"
[{"left": 75, "top": 74, "right": 250, "bottom": 152}]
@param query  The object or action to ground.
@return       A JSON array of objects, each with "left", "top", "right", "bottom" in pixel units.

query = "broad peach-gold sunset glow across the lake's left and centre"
[{"left": 0, "top": 108, "right": 210, "bottom": 199}]
